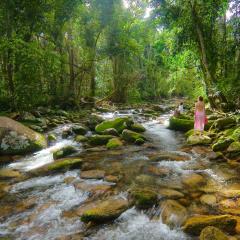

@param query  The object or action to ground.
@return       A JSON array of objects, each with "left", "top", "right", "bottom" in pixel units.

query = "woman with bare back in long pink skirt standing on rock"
[{"left": 194, "top": 96, "right": 206, "bottom": 135}]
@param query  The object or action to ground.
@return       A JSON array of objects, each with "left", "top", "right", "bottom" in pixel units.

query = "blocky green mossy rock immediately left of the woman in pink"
[{"left": 169, "top": 117, "right": 194, "bottom": 132}]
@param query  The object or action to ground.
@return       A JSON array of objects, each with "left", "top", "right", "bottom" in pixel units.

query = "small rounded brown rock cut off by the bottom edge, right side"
[{"left": 200, "top": 226, "right": 229, "bottom": 240}]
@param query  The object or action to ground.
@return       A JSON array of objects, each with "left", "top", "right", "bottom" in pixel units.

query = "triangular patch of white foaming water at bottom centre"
[{"left": 85, "top": 208, "right": 189, "bottom": 240}]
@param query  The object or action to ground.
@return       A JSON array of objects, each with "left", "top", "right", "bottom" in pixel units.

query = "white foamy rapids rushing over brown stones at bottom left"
[{"left": 4, "top": 171, "right": 88, "bottom": 240}]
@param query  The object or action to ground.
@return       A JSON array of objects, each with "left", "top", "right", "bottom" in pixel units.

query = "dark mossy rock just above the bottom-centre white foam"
[{"left": 131, "top": 188, "right": 158, "bottom": 209}]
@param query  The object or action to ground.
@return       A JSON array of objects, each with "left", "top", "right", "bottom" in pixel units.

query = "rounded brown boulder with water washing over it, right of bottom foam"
[{"left": 161, "top": 200, "right": 187, "bottom": 228}]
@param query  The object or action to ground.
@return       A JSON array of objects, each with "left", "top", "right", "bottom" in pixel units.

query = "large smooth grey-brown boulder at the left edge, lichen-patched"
[{"left": 0, "top": 117, "right": 47, "bottom": 155}]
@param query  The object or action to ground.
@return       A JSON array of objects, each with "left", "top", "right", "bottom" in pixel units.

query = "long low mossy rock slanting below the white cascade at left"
[{"left": 30, "top": 158, "right": 82, "bottom": 176}]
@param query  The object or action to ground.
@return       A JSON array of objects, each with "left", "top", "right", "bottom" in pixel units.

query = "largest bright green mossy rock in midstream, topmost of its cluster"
[{"left": 95, "top": 117, "right": 128, "bottom": 133}]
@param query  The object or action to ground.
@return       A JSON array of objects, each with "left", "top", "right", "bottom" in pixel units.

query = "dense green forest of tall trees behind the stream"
[{"left": 0, "top": 0, "right": 240, "bottom": 110}]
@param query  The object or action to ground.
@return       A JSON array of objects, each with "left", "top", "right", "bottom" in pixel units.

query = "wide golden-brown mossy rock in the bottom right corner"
[{"left": 183, "top": 215, "right": 237, "bottom": 236}]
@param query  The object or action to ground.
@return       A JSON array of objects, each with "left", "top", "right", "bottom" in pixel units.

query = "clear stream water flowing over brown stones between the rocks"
[{"left": 0, "top": 111, "right": 239, "bottom": 240}]
